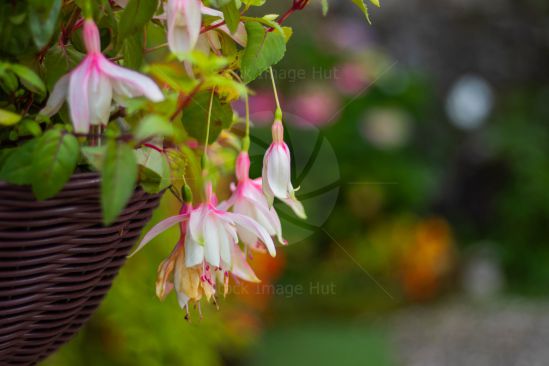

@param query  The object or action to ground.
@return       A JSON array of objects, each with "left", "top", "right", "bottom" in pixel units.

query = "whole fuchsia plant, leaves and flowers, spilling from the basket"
[{"left": 0, "top": 0, "right": 377, "bottom": 312}]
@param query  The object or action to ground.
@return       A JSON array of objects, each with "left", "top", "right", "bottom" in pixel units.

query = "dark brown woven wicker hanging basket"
[{"left": 0, "top": 173, "right": 160, "bottom": 366}]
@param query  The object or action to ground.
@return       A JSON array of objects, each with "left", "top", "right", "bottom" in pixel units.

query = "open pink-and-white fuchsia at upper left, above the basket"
[{"left": 40, "top": 19, "right": 164, "bottom": 133}]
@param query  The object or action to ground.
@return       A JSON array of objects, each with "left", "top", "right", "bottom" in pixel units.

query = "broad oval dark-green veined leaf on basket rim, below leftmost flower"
[{"left": 32, "top": 129, "right": 79, "bottom": 200}]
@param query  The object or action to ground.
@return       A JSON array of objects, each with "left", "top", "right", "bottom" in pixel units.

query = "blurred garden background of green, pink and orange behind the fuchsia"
[{"left": 44, "top": 0, "right": 549, "bottom": 366}]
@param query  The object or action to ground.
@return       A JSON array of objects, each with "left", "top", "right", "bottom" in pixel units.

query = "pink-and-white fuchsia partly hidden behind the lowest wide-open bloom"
[{"left": 220, "top": 151, "right": 286, "bottom": 250}]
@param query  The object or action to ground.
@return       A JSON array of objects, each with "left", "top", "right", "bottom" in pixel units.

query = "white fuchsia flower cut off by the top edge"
[{"left": 164, "top": 0, "right": 202, "bottom": 58}]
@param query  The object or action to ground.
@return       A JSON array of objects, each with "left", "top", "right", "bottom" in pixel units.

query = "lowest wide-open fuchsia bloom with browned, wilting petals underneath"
[{"left": 132, "top": 184, "right": 276, "bottom": 309}]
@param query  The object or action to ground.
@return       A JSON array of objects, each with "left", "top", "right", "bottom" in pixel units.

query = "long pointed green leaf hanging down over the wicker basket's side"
[{"left": 101, "top": 141, "right": 137, "bottom": 225}]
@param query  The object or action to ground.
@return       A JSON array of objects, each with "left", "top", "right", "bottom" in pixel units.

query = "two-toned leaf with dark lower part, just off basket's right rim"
[{"left": 135, "top": 147, "right": 171, "bottom": 193}]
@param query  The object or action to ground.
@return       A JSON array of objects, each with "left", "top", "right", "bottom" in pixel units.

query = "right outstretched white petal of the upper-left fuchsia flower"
[{"left": 99, "top": 55, "right": 164, "bottom": 102}]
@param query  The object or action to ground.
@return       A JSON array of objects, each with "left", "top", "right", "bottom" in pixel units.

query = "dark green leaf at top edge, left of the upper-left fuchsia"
[{"left": 28, "top": 0, "right": 62, "bottom": 49}]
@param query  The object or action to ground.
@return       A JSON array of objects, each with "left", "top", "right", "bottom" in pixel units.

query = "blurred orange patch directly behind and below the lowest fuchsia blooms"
[{"left": 233, "top": 247, "right": 286, "bottom": 311}]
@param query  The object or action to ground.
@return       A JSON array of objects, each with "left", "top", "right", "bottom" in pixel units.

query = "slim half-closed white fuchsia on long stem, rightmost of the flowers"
[{"left": 262, "top": 120, "right": 306, "bottom": 218}]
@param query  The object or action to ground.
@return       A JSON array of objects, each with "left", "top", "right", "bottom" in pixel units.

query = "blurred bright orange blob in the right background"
[{"left": 402, "top": 218, "right": 454, "bottom": 301}]
